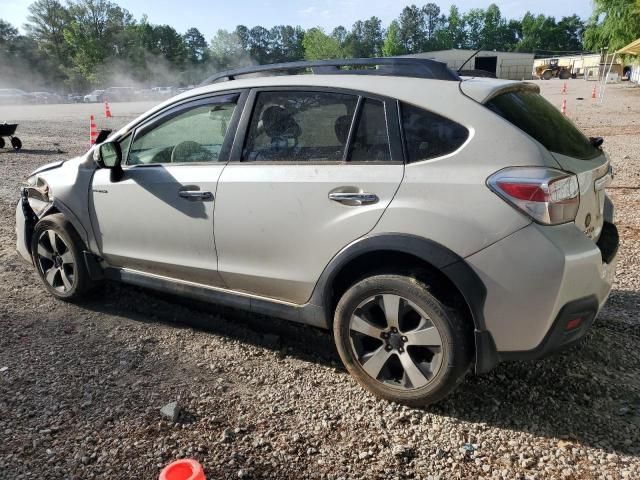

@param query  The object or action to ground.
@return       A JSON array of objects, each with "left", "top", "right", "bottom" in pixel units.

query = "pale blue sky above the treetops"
[{"left": 0, "top": 0, "right": 593, "bottom": 40}]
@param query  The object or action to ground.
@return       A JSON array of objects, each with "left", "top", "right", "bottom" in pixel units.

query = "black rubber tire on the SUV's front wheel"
[{"left": 31, "top": 213, "right": 96, "bottom": 301}]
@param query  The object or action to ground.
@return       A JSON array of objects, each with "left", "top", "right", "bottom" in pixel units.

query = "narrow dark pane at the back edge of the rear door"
[{"left": 349, "top": 99, "right": 391, "bottom": 162}]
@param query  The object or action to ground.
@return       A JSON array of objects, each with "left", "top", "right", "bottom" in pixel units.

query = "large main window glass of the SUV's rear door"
[{"left": 242, "top": 91, "right": 358, "bottom": 162}]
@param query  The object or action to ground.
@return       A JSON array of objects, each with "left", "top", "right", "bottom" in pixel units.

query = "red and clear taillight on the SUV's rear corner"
[{"left": 487, "top": 167, "right": 580, "bottom": 225}]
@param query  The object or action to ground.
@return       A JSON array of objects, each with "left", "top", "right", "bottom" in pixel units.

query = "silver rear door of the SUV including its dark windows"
[{"left": 215, "top": 88, "right": 404, "bottom": 304}]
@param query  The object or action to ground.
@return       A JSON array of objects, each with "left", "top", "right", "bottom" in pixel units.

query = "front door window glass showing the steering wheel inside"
[{"left": 126, "top": 100, "right": 236, "bottom": 165}]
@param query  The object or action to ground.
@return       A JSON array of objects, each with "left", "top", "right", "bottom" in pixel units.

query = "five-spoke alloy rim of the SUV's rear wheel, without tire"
[{"left": 349, "top": 293, "right": 442, "bottom": 390}]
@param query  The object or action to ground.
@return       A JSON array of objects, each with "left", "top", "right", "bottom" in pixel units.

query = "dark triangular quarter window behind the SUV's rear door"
[{"left": 402, "top": 103, "right": 469, "bottom": 163}]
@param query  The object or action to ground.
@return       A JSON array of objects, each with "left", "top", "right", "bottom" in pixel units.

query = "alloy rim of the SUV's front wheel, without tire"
[{"left": 36, "top": 230, "right": 76, "bottom": 293}]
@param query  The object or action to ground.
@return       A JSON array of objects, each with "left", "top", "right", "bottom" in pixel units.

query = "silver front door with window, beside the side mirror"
[{"left": 90, "top": 92, "right": 246, "bottom": 286}]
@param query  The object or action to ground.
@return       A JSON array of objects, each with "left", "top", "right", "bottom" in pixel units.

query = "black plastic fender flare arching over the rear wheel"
[{"left": 309, "top": 233, "right": 499, "bottom": 373}]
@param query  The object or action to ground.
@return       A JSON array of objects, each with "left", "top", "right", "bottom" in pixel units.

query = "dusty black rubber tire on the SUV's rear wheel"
[{"left": 333, "top": 275, "right": 473, "bottom": 406}]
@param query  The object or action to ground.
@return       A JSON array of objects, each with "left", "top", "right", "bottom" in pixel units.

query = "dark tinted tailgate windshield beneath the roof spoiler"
[{"left": 486, "top": 91, "right": 602, "bottom": 160}]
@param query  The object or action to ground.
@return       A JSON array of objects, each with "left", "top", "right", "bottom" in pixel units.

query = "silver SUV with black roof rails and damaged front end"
[{"left": 16, "top": 59, "right": 618, "bottom": 405}]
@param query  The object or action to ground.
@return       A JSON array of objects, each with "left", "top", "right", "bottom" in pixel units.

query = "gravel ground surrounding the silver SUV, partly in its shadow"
[{"left": 0, "top": 80, "right": 640, "bottom": 480}]
